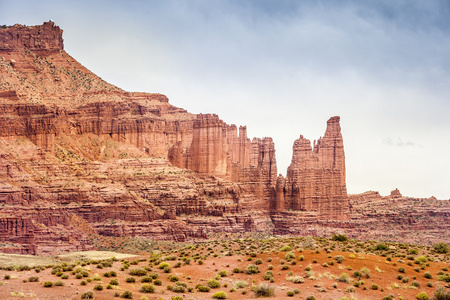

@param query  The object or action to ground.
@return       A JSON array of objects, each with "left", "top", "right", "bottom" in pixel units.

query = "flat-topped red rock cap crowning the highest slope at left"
[{"left": 0, "top": 21, "right": 64, "bottom": 53}]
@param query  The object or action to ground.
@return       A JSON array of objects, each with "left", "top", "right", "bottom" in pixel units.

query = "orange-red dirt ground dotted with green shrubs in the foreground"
[{"left": 0, "top": 241, "right": 450, "bottom": 300}]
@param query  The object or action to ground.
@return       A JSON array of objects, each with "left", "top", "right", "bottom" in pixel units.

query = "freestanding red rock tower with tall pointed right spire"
[{"left": 282, "top": 117, "right": 350, "bottom": 220}]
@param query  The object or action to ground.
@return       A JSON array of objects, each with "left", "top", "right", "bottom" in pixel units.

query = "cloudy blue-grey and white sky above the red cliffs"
[{"left": 0, "top": 0, "right": 450, "bottom": 199}]
